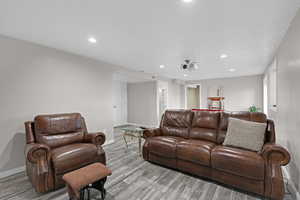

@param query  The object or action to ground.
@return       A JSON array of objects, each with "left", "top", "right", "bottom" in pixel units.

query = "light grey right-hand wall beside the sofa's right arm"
[{"left": 276, "top": 11, "right": 300, "bottom": 195}]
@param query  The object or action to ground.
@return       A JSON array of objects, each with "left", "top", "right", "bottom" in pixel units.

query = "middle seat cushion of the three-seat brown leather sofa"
[{"left": 177, "top": 140, "right": 215, "bottom": 166}]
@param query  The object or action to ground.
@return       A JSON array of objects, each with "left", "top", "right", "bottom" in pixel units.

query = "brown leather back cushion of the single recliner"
[{"left": 34, "top": 113, "right": 86, "bottom": 148}]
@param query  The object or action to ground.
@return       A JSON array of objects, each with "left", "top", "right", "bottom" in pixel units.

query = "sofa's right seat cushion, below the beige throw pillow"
[{"left": 211, "top": 146, "right": 265, "bottom": 181}]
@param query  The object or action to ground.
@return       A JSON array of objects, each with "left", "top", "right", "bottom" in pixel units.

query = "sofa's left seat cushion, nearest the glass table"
[{"left": 148, "top": 136, "right": 183, "bottom": 158}]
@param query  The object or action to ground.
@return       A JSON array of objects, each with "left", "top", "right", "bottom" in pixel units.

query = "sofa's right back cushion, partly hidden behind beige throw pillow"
[{"left": 217, "top": 111, "right": 267, "bottom": 144}]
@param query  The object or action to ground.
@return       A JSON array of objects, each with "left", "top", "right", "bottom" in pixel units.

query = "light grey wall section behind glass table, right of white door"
[{"left": 127, "top": 81, "right": 158, "bottom": 126}]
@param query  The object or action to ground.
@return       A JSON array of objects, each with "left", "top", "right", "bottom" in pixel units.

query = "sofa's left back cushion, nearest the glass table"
[{"left": 160, "top": 110, "right": 193, "bottom": 138}]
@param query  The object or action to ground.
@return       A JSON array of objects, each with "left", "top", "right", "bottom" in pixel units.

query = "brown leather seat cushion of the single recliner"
[{"left": 51, "top": 143, "right": 99, "bottom": 174}]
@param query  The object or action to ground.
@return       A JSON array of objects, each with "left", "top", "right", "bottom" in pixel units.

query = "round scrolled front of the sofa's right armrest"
[{"left": 261, "top": 143, "right": 291, "bottom": 166}]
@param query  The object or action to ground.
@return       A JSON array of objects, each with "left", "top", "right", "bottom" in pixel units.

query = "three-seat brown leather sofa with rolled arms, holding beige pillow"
[{"left": 143, "top": 110, "right": 290, "bottom": 200}]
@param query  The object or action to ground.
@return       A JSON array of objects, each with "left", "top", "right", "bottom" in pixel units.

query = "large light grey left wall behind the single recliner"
[{"left": 0, "top": 36, "right": 113, "bottom": 172}]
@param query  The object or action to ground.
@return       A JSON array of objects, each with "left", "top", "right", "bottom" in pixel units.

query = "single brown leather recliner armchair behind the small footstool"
[{"left": 25, "top": 113, "right": 106, "bottom": 193}]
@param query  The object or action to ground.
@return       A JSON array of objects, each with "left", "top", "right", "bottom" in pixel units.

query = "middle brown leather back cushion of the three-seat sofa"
[{"left": 190, "top": 111, "right": 220, "bottom": 143}]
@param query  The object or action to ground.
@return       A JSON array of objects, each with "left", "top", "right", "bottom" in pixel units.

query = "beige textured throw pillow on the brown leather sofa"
[{"left": 223, "top": 118, "right": 267, "bottom": 151}]
